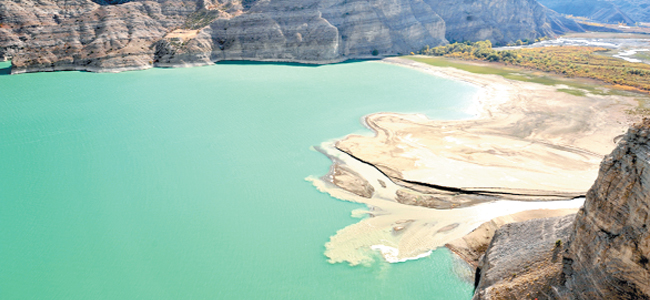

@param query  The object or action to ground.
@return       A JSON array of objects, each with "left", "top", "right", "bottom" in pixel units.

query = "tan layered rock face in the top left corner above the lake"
[{"left": 0, "top": 0, "right": 202, "bottom": 72}]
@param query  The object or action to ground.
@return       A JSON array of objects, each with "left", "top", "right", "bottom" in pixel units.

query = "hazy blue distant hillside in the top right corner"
[{"left": 538, "top": 0, "right": 650, "bottom": 25}]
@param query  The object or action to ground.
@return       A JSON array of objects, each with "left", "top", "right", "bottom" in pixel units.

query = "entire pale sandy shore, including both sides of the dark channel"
[{"left": 309, "top": 58, "right": 637, "bottom": 264}]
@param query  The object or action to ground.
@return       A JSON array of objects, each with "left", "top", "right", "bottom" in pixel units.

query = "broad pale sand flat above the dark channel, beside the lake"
[{"left": 336, "top": 58, "right": 638, "bottom": 193}]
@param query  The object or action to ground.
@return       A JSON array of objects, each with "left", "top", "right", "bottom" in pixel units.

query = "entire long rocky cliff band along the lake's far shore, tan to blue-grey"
[{"left": 0, "top": 0, "right": 553, "bottom": 73}]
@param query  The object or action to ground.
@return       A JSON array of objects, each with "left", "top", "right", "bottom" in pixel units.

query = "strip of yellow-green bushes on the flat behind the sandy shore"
[{"left": 420, "top": 41, "right": 650, "bottom": 91}]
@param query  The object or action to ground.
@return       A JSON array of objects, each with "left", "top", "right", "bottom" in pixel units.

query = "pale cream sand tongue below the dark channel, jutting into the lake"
[{"left": 305, "top": 141, "right": 584, "bottom": 265}]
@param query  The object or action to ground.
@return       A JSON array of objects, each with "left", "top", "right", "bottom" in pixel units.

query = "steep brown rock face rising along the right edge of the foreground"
[{"left": 565, "top": 120, "right": 650, "bottom": 299}]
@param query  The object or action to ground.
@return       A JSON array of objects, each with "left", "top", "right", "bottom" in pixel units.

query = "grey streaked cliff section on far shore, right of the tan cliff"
[{"left": 159, "top": 0, "right": 445, "bottom": 65}]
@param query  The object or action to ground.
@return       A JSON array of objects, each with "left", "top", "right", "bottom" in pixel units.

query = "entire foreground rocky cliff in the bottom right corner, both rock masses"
[{"left": 474, "top": 120, "right": 650, "bottom": 300}]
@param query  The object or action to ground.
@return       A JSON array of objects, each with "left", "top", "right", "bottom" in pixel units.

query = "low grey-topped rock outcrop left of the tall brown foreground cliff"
[{"left": 472, "top": 215, "right": 572, "bottom": 300}]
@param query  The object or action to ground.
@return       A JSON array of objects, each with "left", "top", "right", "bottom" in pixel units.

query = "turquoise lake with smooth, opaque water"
[{"left": 0, "top": 62, "right": 477, "bottom": 299}]
